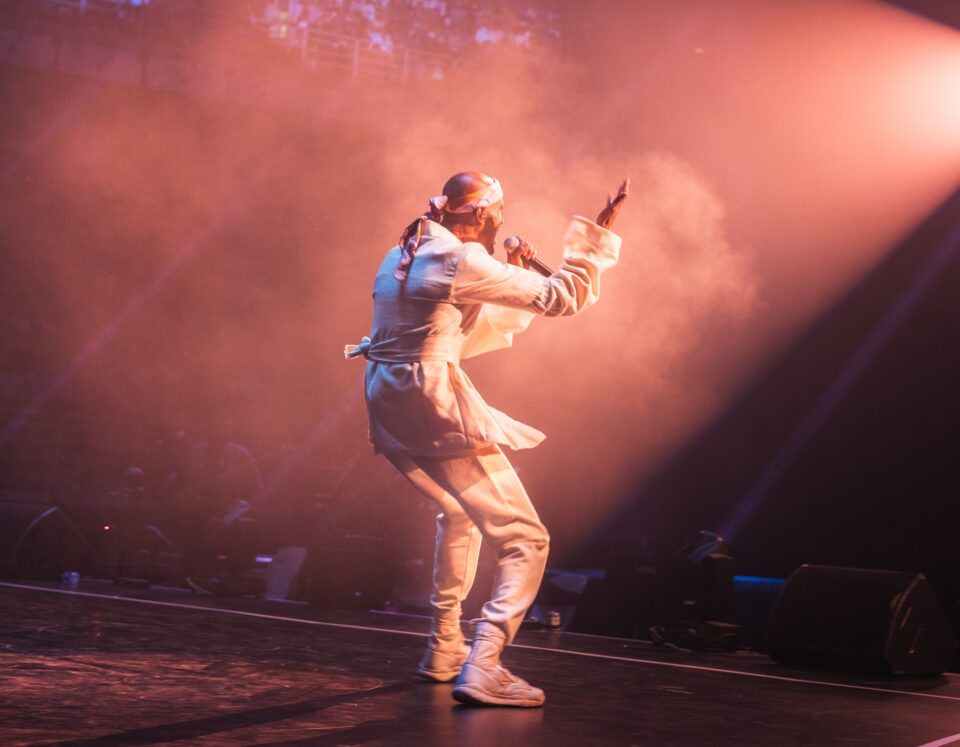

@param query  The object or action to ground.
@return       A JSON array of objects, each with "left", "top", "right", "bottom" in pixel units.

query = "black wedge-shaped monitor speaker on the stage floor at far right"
[{"left": 767, "top": 565, "right": 957, "bottom": 674}]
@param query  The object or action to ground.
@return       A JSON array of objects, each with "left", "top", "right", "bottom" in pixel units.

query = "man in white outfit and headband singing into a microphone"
[{"left": 345, "top": 171, "right": 629, "bottom": 706}]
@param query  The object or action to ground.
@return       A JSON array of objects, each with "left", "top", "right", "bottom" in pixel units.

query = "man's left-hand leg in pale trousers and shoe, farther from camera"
[{"left": 391, "top": 457, "right": 481, "bottom": 682}]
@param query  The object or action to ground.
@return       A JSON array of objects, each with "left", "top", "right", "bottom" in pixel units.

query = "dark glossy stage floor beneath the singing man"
[{"left": 0, "top": 582, "right": 960, "bottom": 747}]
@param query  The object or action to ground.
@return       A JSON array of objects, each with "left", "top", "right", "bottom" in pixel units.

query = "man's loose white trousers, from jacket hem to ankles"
[{"left": 389, "top": 445, "right": 550, "bottom": 643}]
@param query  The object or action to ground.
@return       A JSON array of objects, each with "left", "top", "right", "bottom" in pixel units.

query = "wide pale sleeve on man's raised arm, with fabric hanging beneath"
[{"left": 451, "top": 216, "right": 621, "bottom": 358}]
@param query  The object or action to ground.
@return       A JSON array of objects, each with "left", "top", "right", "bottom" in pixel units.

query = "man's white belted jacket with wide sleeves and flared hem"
[{"left": 362, "top": 216, "right": 621, "bottom": 456}]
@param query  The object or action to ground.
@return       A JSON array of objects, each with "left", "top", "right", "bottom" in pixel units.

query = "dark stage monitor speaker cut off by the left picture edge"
[{"left": 0, "top": 503, "right": 93, "bottom": 579}]
